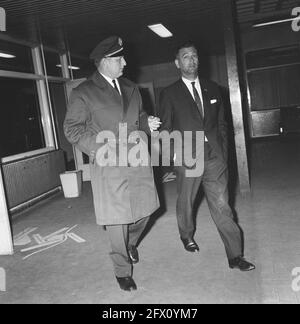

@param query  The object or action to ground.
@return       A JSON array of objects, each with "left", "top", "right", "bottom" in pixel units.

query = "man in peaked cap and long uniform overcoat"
[{"left": 64, "top": 36, "right": 160, "bottom": 291}]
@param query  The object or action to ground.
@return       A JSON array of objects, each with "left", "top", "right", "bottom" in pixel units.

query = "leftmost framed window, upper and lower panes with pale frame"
[{"left": 0, "top": 41, "right": 56, "bottom": 162}]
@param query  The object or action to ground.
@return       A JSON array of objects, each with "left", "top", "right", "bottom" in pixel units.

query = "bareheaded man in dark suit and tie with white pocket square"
[{"left": 159, "top": 43, "right": 255, "bottom": 271}]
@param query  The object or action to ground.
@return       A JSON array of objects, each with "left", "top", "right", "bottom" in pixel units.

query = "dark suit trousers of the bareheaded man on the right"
[{"left": 175, "top": 143, "right": 242, "bottom": 259}]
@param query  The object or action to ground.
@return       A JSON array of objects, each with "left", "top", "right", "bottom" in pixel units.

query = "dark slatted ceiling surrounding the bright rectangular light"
[{"left": 0, "top": 0, "right": 300, "bottom": 65}]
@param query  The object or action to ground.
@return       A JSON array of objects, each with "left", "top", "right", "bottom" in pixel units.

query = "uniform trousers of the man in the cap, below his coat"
[{"left": 106, "top": 217, "right": 149, "bottom": 277}]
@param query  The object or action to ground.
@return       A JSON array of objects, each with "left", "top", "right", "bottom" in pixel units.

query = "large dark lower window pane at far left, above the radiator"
[{"left": 0, "top": 77, "right": 45, "bottom": 157}]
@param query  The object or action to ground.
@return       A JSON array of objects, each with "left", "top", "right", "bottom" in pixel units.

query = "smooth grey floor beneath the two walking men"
[{"left": 0, "top": 137, "right": 300, "bottom": 304}]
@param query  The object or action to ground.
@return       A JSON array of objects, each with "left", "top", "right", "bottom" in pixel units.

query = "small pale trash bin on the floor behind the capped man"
[{"left": 60, "top": 170, "right": 82, "bottom": 198}]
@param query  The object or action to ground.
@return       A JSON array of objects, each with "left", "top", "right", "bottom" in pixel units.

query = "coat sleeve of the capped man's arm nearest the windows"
[{"left": 64, "top": 89, "right": 98, "bottom": 157}]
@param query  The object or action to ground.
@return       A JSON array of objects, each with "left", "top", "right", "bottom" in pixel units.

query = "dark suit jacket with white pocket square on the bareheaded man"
[{"left": 159, "top": 78, "right": 228, "bottom": 163}]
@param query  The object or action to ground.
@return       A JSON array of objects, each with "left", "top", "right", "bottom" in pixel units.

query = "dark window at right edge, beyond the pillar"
[{"left": 246, "top": 45, "right": 300, "bottom": 111}]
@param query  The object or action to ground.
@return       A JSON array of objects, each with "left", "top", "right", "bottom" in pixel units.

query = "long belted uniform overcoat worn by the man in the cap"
[{"left": 64, "top": 71, "right": 159, "bottom": 225}]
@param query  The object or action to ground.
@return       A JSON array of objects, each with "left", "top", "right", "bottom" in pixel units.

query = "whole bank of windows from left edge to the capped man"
[{"left": 0, "top": 40, "right": 77, "bottom": 163}]
